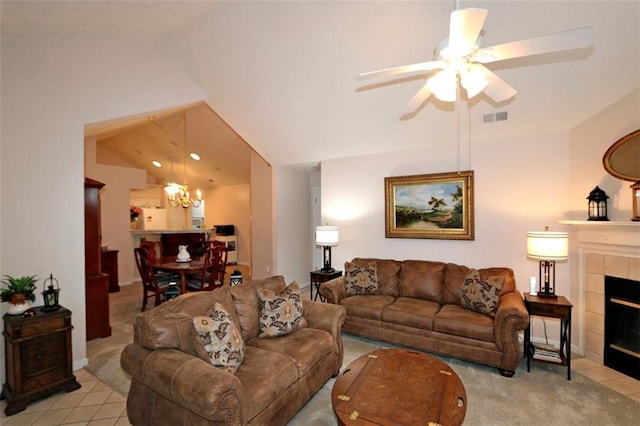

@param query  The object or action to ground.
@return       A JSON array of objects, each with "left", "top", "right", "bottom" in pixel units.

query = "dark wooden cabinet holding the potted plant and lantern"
[{"left": 0, "top": 307, "right": 80, "bottom": 416}]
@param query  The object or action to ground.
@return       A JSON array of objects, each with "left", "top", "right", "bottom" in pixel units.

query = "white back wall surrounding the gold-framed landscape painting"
[{"left": 321, "top": 132, "right": 570, "bottom": 346}]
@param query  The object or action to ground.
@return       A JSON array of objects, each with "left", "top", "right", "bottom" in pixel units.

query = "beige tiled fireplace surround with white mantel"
[{"left": 561, "top": 221, "right": 640, "bottom": 365}]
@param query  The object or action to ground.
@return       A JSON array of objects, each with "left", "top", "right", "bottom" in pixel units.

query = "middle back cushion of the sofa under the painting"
[{"left": 398, "top": 260, "right": 445, "bottom": 303}]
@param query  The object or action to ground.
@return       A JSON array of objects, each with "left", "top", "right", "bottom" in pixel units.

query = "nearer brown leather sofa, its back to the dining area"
[{"left": 120, "top": 276, "right": 345, "bottom": 426}]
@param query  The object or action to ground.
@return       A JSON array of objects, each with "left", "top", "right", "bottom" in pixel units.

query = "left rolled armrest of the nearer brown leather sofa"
[{"left": 120, "top": 343, "right": 247, "bottom": 424}]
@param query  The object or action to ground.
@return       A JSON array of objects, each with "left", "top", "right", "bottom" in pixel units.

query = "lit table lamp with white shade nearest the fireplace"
[{"left": 527, "top": 227, "right": 569, "bottom": 298}]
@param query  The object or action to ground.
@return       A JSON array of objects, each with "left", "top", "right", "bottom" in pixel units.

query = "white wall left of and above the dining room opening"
[{"left": 0, "top": 43, "right": 203, "bottom": 382}]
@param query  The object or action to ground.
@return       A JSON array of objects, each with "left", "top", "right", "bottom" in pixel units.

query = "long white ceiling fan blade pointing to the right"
[{"left": 471, "top": 27, "right": 596, "bottom": 64}]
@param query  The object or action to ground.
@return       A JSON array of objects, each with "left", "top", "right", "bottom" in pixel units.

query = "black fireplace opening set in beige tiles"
[{"left": 604, "top": 275, "right": 640, "bottom": 380}]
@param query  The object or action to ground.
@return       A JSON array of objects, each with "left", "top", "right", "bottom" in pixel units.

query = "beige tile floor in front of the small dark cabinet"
[{"left": 0, "top": 369, "right": 130, "bottom": 426}]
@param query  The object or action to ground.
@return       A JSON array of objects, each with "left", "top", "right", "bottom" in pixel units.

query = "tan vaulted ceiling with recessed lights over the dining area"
[{"left": 85, "top": 102, "right": 252, "bottom": 190}]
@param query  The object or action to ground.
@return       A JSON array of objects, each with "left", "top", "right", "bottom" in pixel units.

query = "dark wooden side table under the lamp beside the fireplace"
[{"left": 524, "top": 293, "right": 573, "bottom": 380}]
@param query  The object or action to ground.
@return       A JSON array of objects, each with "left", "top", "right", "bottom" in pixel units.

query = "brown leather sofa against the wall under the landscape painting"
[{"left": 320, "top": 258, "right": 529, "bottom": 377}]
